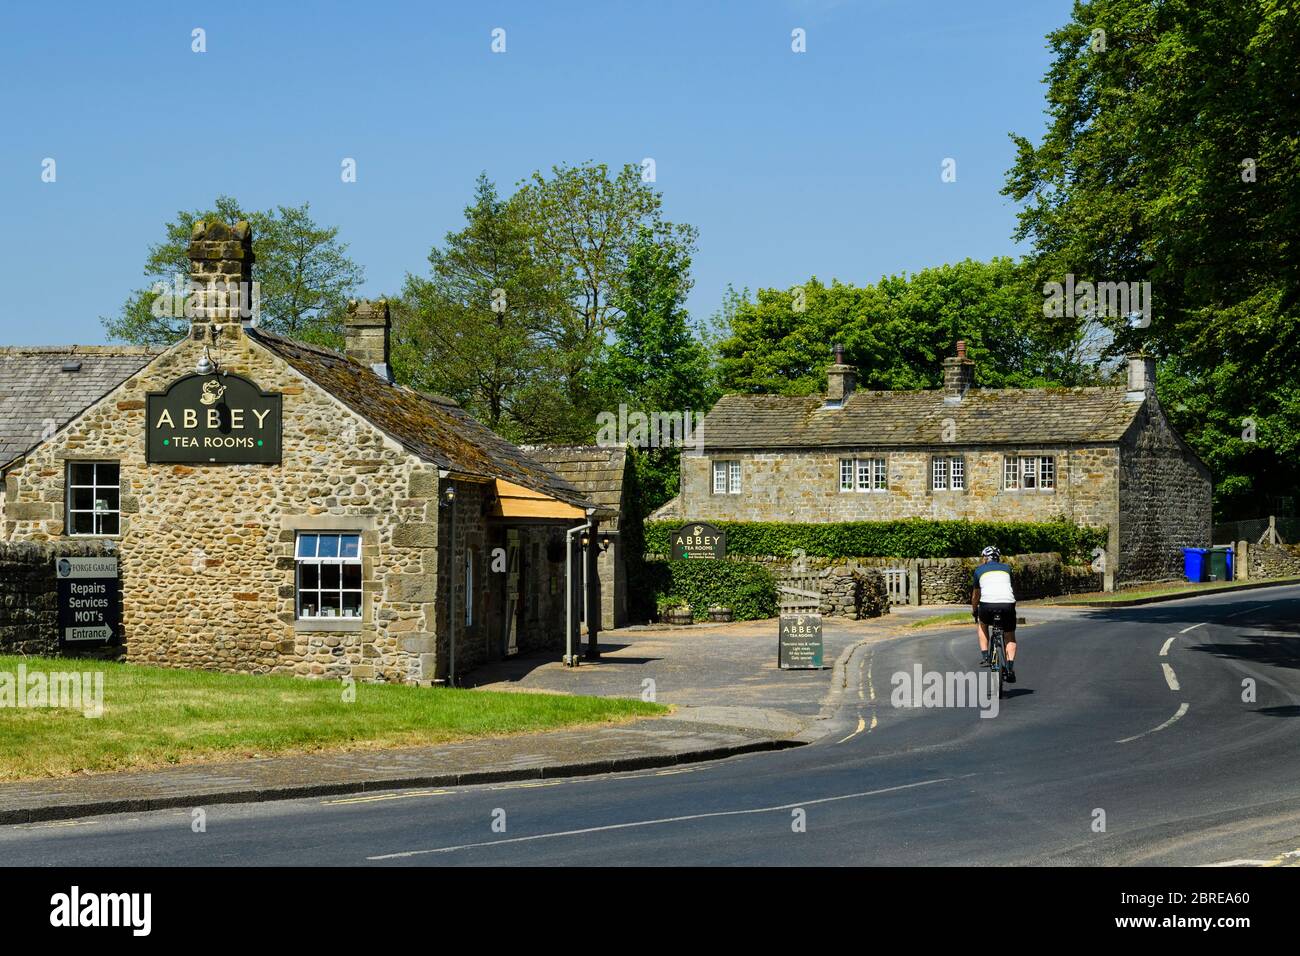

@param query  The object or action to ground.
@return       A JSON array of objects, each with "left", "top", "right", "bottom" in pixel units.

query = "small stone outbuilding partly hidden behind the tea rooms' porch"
[{"left": 524, "top": 445, "right": 640, "bottom": 628}]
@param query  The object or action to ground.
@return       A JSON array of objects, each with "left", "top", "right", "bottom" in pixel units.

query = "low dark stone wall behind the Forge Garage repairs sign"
[{"left": 0, "top": 541, "right": 121, "bottom": 657}]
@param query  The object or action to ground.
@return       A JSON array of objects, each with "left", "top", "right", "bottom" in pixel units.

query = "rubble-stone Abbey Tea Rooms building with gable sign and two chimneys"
[{"left": 0, "top": 222, "right": 612, "bottom": 682}]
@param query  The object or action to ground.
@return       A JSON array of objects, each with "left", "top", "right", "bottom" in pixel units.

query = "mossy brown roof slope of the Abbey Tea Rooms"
[{"left": 247, "top": 329, "right": 603, "bottom": 511}]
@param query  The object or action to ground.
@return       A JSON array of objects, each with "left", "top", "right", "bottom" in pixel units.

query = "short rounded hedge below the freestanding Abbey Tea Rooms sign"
[{"left": 641, "top": 558, "right": 776, "bottom": 620}]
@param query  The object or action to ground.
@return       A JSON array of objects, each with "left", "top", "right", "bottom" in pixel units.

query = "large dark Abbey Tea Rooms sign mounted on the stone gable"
[{"left": 144, "top": 372, "right": 281, "bottom": 464}]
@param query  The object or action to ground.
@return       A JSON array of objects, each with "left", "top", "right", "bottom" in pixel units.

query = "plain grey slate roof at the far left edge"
[{"left": 0, "top": 345, "right": 163, "bottom": 466}]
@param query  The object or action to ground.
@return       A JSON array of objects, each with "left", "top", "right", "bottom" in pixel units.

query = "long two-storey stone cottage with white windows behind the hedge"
[{"left": 654, "top": 342, "right": 1212, "bottom": 588}]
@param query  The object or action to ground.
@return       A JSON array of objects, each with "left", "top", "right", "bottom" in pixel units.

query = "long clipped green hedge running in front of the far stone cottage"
[{"left": 645, "top": 518, "right": 1106, "bottom": 563}]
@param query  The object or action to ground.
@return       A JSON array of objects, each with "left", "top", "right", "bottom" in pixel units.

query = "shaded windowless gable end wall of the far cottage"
[{"left": 1114, "top": 397, "right": 1213, "bottom": 584}]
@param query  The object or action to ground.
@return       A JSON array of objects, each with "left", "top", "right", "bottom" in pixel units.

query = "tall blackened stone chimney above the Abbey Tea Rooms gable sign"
[{"left": 187, "top": 220, "right": 256, "bottom": 339}]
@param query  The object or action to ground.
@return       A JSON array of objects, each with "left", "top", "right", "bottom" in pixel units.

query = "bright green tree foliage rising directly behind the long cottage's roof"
[{"left": 718, "top": 259, "right": 1050, "bottom": 394}]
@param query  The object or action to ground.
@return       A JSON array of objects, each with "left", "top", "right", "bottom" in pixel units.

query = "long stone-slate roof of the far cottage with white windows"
[{"left": 702, "top": 388, "right": 1143, "bottom": 451}]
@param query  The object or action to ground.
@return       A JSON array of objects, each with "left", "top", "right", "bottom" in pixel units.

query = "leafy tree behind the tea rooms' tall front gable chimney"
[{"left": 100, "top": 196, "right": 364, "bottom": 346}]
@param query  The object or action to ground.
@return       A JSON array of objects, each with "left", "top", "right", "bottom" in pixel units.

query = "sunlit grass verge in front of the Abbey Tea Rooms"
[{"left": 0, "top": 656, "right": 668, "bottom": 780}]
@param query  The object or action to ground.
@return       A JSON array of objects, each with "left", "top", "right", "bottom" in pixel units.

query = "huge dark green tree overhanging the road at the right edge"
[{"left": 1004, "top": 0, "right": 1300, "bottom": 518}]
